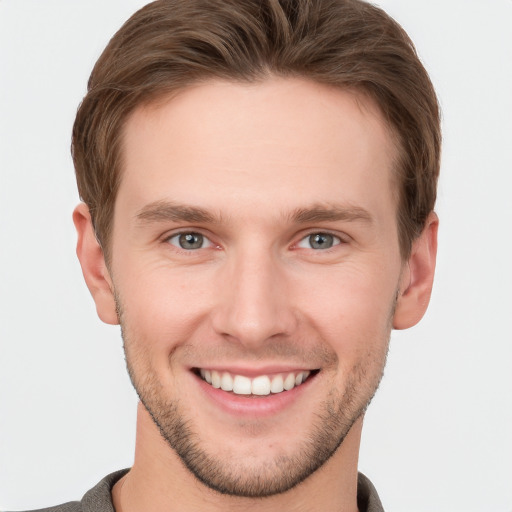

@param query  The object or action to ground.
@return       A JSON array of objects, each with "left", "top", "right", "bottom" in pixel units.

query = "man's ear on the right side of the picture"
[{"left": 393, "top": 212, "right": 439, "bottom": 329}]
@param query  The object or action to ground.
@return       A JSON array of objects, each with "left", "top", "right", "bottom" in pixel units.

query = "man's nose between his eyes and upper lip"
[{"left": 212, "top": 247, "right": 297, "bottom": 349}]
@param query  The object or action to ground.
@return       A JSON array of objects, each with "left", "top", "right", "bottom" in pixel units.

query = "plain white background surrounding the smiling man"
[{"left": 0, "top": 0, "right": 512, "bottom": 512}]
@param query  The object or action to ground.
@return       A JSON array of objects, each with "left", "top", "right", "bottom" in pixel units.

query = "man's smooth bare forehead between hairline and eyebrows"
[{"left": 118, "top": 78, "right": 396, "bottom": 220}]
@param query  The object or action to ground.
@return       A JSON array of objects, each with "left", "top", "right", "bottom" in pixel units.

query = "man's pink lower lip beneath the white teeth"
[{"left": 194, "top": 374, "right": 316, "bottom": 418}]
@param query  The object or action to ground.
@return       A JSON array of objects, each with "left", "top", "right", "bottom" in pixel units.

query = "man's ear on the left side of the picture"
[{"left": 73, "top": 203, "right": 119, "bottom": 325}]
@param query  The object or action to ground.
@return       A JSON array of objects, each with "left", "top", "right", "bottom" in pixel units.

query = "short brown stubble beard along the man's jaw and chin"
[{"left": 117, "top": 301, "right": 389, "bottom": 498}]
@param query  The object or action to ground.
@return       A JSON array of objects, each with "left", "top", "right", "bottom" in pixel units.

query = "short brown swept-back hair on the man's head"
[{"left": 72, "top": 0, "right": 441, "bottom": 260}]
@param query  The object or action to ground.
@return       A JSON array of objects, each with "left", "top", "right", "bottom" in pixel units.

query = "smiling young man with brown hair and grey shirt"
[{"left": 19, "top": 0, "right": 440, "bottom": 512}]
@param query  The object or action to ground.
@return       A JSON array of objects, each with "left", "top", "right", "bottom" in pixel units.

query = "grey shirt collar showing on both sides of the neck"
[{"left": 13, "top": 469, "right": 384, "bottom": 512}]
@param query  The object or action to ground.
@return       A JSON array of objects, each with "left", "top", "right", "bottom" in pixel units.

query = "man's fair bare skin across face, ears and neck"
[{"left": 74, "top": 78, "right": 438, "bottom": 512}]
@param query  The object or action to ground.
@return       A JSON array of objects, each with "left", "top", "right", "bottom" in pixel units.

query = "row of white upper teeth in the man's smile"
[{"left": 199, "top": 368, "right": 311, "bottom": 396}]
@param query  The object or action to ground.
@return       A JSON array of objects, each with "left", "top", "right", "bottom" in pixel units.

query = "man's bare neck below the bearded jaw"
[{"left": 112, "top": 404, "right": 362, "bottom": 512}]
